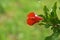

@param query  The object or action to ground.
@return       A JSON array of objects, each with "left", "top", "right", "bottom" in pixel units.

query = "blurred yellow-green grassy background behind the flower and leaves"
[{"left": 0, "top": 0, "right": 60, "bottom": 40}]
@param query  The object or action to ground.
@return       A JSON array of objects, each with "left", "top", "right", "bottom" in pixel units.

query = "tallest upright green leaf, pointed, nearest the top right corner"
[{"left": 50, "top": 2, "right": 58, "bottom": 24}]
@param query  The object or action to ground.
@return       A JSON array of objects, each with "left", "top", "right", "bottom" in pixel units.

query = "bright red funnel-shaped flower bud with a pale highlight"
[{"left": 27, "top": 12, "right": 43, "bottom": 25}]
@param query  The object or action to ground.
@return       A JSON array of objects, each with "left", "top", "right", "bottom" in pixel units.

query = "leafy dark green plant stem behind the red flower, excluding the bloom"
[{"left": 27, "top": 2, "right": 60, "bottom": 40}]
